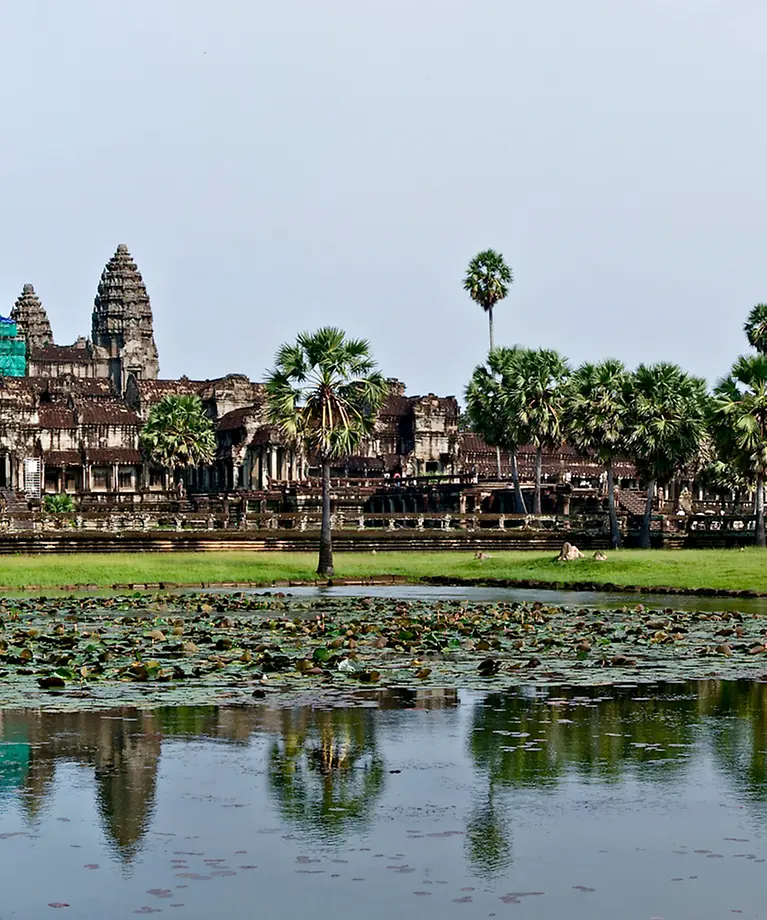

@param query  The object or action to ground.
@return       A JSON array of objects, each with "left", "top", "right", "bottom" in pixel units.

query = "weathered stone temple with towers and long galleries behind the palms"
[{"left": 0, "top": 244, "right": 660, "bottom": 514}]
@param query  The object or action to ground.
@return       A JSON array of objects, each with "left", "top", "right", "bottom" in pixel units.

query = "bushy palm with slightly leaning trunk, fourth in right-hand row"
[{"left": 626, "top": 362, "right": 708, "bottom": 549}]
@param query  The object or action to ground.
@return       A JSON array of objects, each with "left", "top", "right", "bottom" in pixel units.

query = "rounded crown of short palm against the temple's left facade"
[{"left": 141, "top": 396, "right": 216, "bottom": 482}]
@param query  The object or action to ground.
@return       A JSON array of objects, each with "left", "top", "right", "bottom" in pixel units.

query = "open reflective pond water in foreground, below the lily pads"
[{"left": 0, "top": 682, "right": 767, "bottom": 920}]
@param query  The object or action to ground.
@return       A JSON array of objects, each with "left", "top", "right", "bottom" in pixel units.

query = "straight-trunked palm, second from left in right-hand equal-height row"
[{"left": 510, "top": 348, "right": 570, "bottom": 514}]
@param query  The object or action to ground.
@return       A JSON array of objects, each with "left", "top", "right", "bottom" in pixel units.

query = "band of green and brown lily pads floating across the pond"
[{"left": 0, "top": 593, "right": 767, "bottom": 708}]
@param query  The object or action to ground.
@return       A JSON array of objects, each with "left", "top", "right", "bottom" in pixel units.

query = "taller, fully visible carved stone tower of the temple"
[{"left": 92, "top": 243, "right": 160, "bottom": 393}]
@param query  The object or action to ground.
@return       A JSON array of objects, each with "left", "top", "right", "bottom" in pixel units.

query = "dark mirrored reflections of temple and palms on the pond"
[{"left": 0, "top": 681, "right": 767, "bottom": 878}]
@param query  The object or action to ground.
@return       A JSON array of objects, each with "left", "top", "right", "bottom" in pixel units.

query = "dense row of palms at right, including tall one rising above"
[{"left": 464, "top": 250, "right": 767, "bottom": 547}]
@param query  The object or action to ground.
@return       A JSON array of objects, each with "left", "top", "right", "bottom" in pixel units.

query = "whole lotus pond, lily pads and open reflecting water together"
[{"left": 0, "top": 591, "right": 767, "bottom": 920}]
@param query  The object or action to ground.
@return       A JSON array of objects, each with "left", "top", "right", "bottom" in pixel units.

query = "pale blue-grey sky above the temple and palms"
[{"left": 0, "top": 0, "right": 767, "bottom": 395}]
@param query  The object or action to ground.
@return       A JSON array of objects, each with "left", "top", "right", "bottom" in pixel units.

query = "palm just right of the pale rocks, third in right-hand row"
[{"left": 564, "top": 358, "right": 629, "bottom": 549}]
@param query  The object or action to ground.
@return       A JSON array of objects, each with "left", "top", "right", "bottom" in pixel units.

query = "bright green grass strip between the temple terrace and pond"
[{"left": 0, "top": 549, "right": 767, "bottom": 592}]
